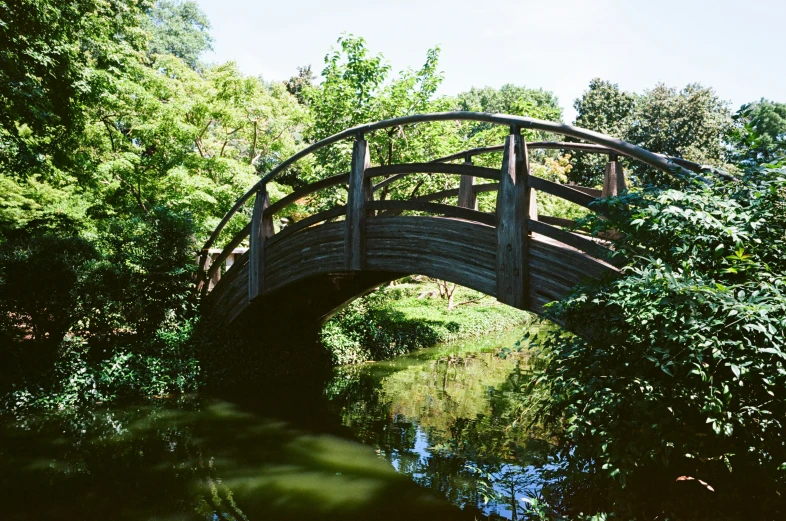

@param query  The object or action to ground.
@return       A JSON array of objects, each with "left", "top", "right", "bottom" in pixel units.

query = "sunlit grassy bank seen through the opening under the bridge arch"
[{"left": 321, "top": 277, "right": 534, "bottom": 365}]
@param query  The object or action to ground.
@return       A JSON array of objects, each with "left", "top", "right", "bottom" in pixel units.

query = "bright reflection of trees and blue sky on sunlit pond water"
[{"left": 332, "top": 353, "right": 549, "bottom": 519}]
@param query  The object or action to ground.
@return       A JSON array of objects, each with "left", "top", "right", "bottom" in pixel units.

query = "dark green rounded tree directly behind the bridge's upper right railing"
[{"left": 569, "top": 78, "right": 636, "bottom": 186}]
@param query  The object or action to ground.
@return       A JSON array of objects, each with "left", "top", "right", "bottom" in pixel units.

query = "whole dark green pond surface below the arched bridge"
[{"left": 0, "top": 332, "right": 548, "bottom": 521}]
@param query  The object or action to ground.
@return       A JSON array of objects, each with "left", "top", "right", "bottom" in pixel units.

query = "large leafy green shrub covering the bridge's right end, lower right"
[{"left": 533, "top": 162, "right": 786, "bottom": 519}]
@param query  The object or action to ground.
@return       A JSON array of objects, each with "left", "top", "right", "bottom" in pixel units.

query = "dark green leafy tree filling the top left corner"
[{"left": 0, "top": 0, "right": 146, "bottom": 176}]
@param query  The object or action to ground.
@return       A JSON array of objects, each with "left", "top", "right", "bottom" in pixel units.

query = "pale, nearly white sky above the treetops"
[{"left": 197, "top": 0, "right": 786, "bottom": 122}]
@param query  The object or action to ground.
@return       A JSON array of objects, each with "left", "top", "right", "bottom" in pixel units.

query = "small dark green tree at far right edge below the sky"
[{"left": 730, "top": 99, "right": 786, "bottom": 167}]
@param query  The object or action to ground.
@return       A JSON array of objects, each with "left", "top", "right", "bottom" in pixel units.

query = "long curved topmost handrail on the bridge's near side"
[{"left": 200, "top": 111, "right": 704, "bottom": 258}]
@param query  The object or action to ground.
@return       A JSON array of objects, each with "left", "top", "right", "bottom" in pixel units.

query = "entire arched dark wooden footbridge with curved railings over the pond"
[{"left": 200, "top": 112, "right": 702, "bottom": 324}]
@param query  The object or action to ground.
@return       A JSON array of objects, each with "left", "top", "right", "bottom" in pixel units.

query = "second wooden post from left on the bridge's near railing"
[{"left": 344, "top": 135, "right": 374, "bottom": 271}]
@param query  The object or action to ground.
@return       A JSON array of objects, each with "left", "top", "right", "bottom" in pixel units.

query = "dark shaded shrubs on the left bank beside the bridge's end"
[{"left": 0, "top": 208, "right": 199, "bottom": 408}]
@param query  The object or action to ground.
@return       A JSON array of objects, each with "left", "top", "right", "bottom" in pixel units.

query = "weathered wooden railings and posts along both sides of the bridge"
[{"left": 199, "top": 112, "right": 716, "bottom": 307}]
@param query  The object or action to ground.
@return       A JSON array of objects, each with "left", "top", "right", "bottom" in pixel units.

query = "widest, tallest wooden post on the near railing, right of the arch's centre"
[{"left": 497, "top": 129, "right": 530, "bottom": 309}]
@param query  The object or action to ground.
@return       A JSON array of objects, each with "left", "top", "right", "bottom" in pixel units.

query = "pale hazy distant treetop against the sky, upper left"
[{"left": 146, "top": 0, "right": 213, "bottom": 69}]
